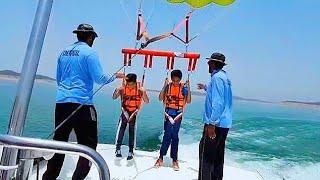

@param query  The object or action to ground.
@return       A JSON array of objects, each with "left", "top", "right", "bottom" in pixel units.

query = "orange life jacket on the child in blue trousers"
[{"left": 165, "top": 83, "right": 186, "bottom": 110}]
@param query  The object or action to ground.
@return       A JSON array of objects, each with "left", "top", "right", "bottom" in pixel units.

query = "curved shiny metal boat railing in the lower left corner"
[{"left": 0, "top": 134, "right": 110, "bottom": 180}]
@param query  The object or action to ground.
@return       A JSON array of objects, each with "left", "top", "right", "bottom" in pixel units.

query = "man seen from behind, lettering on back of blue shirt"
[{"left": 42, "top": 24, "right": 124, "bottom": 180}]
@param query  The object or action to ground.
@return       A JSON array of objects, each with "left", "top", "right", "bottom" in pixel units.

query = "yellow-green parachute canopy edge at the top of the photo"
[{"left": 167, "top": 0, "right": 235, "bottom": 8}]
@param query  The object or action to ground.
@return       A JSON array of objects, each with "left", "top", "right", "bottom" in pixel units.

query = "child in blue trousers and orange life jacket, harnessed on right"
[{"left": 155, "top": 70, "right": 191, "bottom": 171}]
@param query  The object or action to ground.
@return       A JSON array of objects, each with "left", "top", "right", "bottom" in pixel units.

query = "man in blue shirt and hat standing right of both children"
[{"left": 198, "top": 53, "right": 232, "bottom": 180}]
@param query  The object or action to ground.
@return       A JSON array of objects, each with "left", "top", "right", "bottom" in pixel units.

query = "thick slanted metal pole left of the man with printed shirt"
[{"left": 0, "top": 0, "right": 53, "bottom": 180}]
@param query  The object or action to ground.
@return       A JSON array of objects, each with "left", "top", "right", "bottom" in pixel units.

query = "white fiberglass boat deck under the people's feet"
[{"left": 31, "top": 144, "right": 261, "bottom": 180}]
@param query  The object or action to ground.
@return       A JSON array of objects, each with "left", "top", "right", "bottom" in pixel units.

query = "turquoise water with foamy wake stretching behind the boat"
[{"left": 0, "top": 81, "right": 320, "bottom": 180}]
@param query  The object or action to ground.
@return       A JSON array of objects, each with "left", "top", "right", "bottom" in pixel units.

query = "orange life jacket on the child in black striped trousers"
[{"left": 122, "top": 83, "right": 142, "bottom": 112}]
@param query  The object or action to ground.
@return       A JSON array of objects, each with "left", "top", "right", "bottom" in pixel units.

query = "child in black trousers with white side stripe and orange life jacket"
[{"left": 112, "top": 74, "right": 149, "bottom": 160}]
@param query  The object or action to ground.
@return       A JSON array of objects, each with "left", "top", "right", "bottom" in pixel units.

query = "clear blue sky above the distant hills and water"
[{"left": 0, "top": 0, "right": 320, "bottom": 101}]
